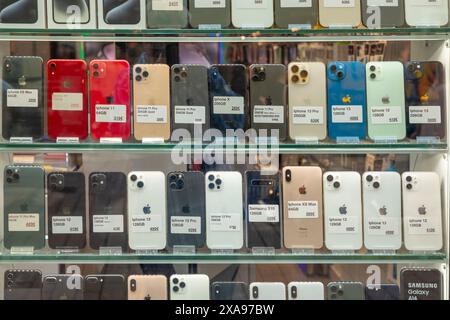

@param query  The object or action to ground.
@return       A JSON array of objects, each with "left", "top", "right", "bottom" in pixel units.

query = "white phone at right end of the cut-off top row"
[{"left": 405, "top": 0, "right": 448, "bottom": 27}]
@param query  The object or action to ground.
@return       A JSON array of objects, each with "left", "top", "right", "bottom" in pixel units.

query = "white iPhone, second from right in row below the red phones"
[{"left": 362, "top": 172, "right": 402, "bottom": 250}]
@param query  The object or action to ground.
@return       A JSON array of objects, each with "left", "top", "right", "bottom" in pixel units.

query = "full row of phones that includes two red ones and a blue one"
[{"left": 2, "top": 57, "right": 446, "bottom": 141}]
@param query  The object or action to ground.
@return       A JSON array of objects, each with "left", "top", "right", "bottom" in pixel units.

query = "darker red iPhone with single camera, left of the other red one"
[{"left": 47, "top": 60, "right": 88, "bottom": 140}]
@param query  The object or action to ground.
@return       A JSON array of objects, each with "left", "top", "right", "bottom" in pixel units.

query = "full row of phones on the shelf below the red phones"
[{"left": 4, "top": 166, "right": 443, "bottom": 251}]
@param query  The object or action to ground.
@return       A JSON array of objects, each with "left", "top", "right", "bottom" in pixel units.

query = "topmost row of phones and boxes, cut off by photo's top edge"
[{"left": 0, "top": 0, "right": 448, "bottom": 29}]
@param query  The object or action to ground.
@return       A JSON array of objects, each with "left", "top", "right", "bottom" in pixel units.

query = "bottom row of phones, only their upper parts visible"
[{"left": 4, "top": 268, "right": 442, "bottom": 301}]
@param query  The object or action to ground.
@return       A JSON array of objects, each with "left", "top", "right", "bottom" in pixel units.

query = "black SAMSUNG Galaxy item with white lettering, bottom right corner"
[{"left": 400, "top": 268, "right": 443, "bottom": 300}]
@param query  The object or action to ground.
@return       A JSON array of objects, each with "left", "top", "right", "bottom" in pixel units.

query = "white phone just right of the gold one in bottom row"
[{"left": 169, "top": 274, "right": 210, "bottom": 301}]
